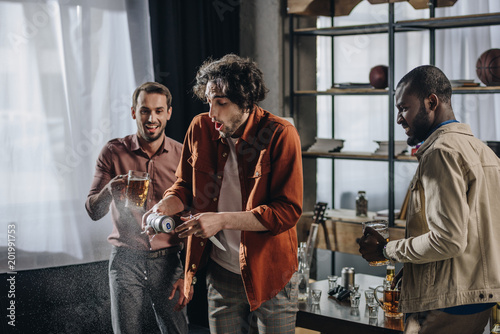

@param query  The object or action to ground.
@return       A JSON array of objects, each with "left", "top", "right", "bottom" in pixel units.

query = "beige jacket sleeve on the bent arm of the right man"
[{"left": 386, "top": 150, "right": 473, "bottom": 263}]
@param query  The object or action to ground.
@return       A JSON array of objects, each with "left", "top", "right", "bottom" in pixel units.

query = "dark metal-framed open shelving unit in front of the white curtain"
[{"left": 289, "top": 0, "right": 500, "bottom": 226}]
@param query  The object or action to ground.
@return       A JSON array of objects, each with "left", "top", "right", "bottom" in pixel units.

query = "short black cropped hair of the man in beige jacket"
[{"left": 397, "top": 65, "right": 452, "bottom": 103}]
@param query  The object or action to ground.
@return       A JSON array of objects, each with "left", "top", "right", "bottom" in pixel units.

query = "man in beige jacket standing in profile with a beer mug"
[{"left": 359, "top": 66, "right": 500, "bottom": 334}]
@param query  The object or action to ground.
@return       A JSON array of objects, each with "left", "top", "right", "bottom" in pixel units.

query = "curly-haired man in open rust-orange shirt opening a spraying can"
[{"left": 153, "top": 55, "right": 303, "bottom": 333}]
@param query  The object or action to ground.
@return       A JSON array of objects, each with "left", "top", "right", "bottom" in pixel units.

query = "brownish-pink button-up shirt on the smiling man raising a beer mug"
[{"left": 85, "top": 134, "right": 182, "bottom": 251}]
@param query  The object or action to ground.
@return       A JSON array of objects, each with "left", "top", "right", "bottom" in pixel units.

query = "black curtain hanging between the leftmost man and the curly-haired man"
[{"left": 149, "top": 0, "right": 240, "bottom": 142}]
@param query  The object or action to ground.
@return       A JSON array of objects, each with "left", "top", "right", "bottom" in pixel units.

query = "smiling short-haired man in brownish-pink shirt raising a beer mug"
[{"left": 85, "top": 82, "right": 188, "bottom": 334}]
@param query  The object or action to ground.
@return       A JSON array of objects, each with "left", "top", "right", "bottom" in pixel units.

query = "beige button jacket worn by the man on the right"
[{"left": 386, "top": 123, "right": 500, "bottom": 313}]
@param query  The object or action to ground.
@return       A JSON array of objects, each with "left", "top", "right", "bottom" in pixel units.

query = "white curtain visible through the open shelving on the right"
[{"left": 317, "top": 0, "right": 500, "bottom": 211}]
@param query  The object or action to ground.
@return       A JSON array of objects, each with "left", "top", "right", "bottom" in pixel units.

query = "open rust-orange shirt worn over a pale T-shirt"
[{"left": 165, "top": 106, "right": 303, "bottom": 310}]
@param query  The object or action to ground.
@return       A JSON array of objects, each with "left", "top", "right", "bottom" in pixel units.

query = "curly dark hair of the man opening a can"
[{"left": 193, "top": 54, "right": 269, "bottom": 110}]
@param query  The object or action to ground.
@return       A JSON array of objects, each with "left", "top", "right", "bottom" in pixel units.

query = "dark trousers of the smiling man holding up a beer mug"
[{"left": 109, "top": 247, "right": 188, "bottom": 334}]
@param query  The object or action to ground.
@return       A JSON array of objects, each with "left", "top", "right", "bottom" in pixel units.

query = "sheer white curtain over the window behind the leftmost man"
[{"left": 0, "top": 0, "right": 154, "bottom": 272}]
